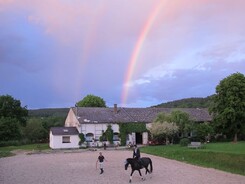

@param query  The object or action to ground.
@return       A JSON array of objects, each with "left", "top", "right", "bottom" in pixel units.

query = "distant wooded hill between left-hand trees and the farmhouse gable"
[{"left": 28, "top": 108, "right": 69, "bottom": 117}]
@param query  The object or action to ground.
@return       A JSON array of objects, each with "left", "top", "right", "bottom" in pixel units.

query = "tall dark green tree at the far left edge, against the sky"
[{"left": 0, "top": 95, "right": 28, "bottom": 126}]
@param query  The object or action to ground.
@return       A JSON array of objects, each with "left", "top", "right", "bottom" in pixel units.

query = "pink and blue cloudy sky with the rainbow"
[{"left": 0, "top": 0, "right": 245, "bottom": 109}]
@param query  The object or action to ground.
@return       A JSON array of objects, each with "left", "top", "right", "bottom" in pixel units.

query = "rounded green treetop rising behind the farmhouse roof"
[{"left": 76, "top": 95, "right": 106, "bottom": 107}]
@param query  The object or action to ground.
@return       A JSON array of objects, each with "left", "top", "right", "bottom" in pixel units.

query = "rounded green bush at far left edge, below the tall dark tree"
[{"left": 0, "top": 117, "right": 21, "bottom": 141}]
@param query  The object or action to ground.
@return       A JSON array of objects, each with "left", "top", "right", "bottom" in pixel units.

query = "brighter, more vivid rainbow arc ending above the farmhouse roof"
[{"left": 121, "top": 0, "right": 164, "bottom": 106}]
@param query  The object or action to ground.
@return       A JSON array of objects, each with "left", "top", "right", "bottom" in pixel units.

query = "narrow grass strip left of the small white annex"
[{"left": 0, "top": 144, "right": 50, "bottom": 158}]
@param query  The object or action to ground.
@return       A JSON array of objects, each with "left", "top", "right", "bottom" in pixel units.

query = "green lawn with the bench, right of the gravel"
[{"left": 141, "top": 142, "right": 245, "bottom": 175}]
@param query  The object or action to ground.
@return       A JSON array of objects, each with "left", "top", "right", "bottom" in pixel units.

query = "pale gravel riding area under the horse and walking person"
[{"left": 0, "top": 150, "right": 245, "bottom": 184}]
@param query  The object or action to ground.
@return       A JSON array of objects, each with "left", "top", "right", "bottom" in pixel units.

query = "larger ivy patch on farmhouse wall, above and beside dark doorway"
[{"left": 119, "top": 123, "right": 148, "bottom": 146}]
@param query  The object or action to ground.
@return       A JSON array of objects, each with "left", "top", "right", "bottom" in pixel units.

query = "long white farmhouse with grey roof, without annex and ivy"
[{"left": 65, "top": 105, "right": 212, "bottom": 146}]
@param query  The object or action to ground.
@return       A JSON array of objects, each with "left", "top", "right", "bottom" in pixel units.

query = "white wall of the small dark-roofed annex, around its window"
[{"left": 49, "top": 132, "right": 80, "bottom": 149}]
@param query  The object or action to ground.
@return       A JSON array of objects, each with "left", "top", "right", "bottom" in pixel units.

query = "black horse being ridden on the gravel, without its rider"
[{"left": 125, "top": 157, "right": 153, "bottom": 183}]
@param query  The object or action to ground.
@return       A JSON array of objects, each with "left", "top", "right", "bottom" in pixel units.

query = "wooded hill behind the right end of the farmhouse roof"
[{"left": 154, "top": 96, "right": 212, "bottom": 108}]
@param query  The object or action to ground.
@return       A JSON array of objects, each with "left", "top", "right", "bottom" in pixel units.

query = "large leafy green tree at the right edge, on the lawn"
[{"left": 210, "top": 73, "right": 245, "bottom": 142}]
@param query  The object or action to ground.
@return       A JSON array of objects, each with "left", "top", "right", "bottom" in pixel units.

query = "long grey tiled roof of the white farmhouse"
[{"left": 72, "top": 107, "right": 212, "bottom": 124}]
